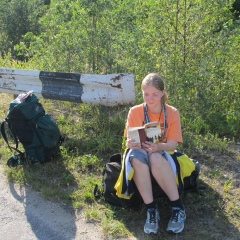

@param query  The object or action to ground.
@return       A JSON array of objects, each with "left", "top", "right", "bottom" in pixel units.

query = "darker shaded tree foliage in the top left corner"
[{"left": 0, "top": 0, "right": 46, "bottom": 60}]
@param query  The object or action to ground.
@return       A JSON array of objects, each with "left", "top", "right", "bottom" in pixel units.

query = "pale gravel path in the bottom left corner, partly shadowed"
[{"left": 0, "top": 167, "right": 104, "bottom": 240}]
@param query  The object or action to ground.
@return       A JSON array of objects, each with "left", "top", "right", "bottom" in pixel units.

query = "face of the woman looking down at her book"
[{"left": 143, "top": 86, "right": 164, "bottom": 108}]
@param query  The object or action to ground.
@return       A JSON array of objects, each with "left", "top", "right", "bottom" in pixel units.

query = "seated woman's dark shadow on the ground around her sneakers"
[{"left": 108, "top": 177, "right": 240, "bottom": 240}]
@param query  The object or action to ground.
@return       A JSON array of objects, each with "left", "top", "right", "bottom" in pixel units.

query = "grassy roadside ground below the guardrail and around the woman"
[{"left": 0, "top": 94, "right": 240, "bottom": 240}]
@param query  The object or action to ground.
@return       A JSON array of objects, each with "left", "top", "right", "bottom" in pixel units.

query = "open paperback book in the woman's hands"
[{"left": 128, "top": 122, "right": 162, "bottom": 143}]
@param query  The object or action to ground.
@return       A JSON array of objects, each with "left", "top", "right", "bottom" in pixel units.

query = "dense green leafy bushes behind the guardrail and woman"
[{"left": 0, "top": 0, "right": 240, "bottom": 138}]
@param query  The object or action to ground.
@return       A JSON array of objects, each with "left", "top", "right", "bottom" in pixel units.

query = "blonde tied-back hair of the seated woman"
[{"left": 141, "top": 73, "right": 168, "bottom": 104}]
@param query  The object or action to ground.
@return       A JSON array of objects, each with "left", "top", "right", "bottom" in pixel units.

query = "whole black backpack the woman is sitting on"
[{"left": 94, "top": 151, "right": 200, "bottom": 210}]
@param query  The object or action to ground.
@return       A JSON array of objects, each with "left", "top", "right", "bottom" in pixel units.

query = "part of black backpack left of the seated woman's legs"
[{"left": 94, "top": 153, "right": 143, "bottom": 210}]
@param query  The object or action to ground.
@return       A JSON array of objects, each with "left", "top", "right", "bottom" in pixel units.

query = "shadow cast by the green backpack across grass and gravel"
[{"left": 9, "top": 157, "right": 77, "bottom": 240}]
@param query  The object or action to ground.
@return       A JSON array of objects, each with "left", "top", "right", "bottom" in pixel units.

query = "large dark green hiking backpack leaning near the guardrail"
[{"left": 1, "top": 91, "right": 63, "bottom": 167}]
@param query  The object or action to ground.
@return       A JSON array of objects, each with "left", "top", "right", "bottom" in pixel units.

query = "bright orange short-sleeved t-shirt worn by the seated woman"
[{"left": 125, "top": 104, "right": 183, "bottom": 143}]
